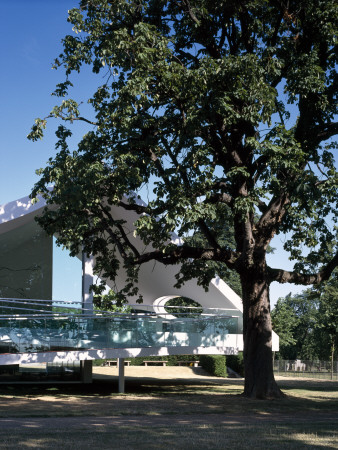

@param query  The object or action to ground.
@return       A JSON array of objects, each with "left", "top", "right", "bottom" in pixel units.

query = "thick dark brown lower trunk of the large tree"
[{"left": 241, "top": 273, "right": 284, "bottom": 399}]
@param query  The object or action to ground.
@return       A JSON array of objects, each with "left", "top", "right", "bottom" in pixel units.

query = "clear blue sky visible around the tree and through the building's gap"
[{"left": 0, "top": 0, "right": 304, "bottom": 303}]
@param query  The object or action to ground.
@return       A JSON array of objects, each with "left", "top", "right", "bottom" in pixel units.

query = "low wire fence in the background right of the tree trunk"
[{"left": 273, "top": 359, "right": 338, "bottom": 381}]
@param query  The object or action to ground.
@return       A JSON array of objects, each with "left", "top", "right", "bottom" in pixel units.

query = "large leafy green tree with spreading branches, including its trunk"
[{"left": 30, "top": 0, "right": 338, "bottom": 397}]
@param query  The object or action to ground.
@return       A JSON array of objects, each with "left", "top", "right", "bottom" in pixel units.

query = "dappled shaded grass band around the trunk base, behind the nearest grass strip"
[{"left": 0, "top": 378, "right": 338, "bottom": 420}]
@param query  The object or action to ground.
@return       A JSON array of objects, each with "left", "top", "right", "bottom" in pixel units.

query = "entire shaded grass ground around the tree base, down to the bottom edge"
[{"left": 0, "top": 370, "right": 338, "bottom": 450}]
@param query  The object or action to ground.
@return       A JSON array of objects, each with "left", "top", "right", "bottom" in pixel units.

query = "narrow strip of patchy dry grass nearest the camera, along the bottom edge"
[{"left": 0, "top": 424, "right": 338, "bottom": 450}]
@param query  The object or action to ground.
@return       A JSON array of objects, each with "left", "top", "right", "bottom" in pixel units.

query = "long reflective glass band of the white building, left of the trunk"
[{"left": 0, "top": 300, "right": 239, "bottom": 353}]
